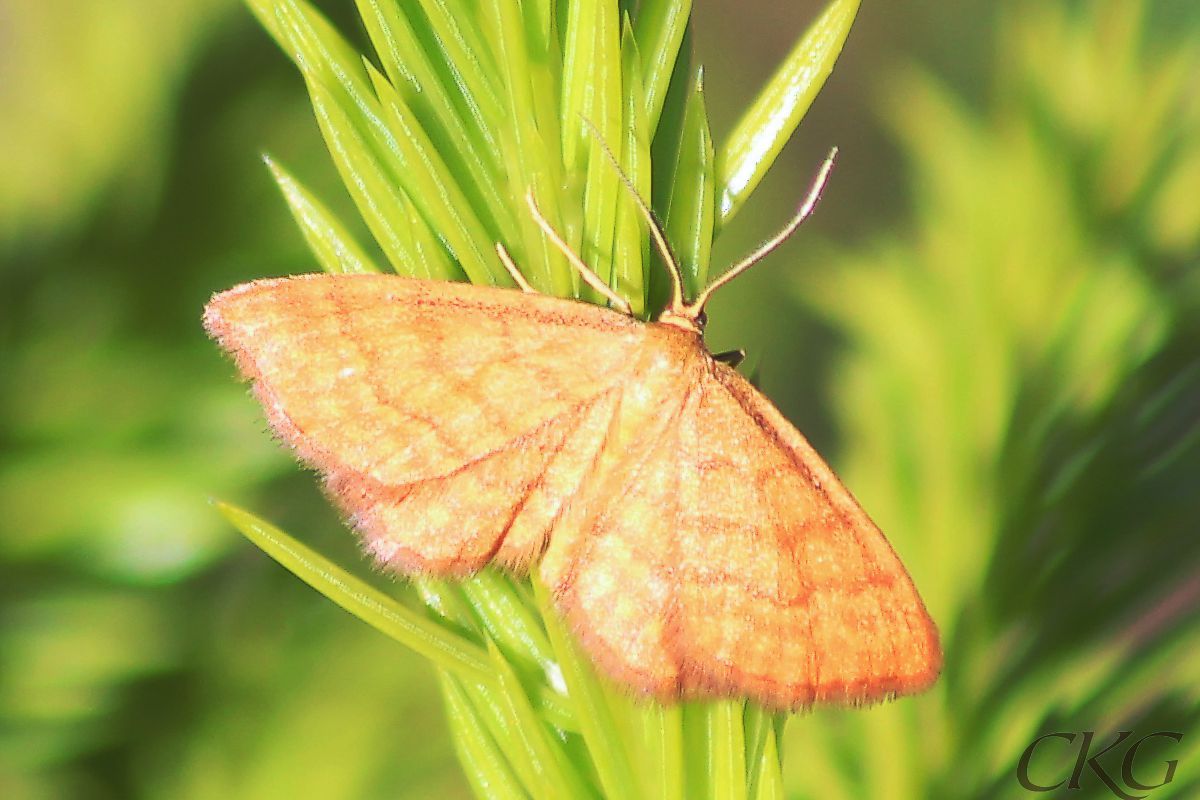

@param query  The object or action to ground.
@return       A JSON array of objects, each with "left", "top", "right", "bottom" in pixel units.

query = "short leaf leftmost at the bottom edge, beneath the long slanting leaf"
[{"left": 438, "top": 670, "right": 528, "bottom": 800}]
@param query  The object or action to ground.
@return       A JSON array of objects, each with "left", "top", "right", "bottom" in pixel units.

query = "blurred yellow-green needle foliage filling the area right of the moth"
[{"left": 788, "top": 0, "right": 1200, "bottom": 800}]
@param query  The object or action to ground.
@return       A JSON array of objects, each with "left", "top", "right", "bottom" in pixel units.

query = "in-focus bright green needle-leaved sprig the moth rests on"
[{"left": 222, "top": 0, "right": 858, "bottom": 799}]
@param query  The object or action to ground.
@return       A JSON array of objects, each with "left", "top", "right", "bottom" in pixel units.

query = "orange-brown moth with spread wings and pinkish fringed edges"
[{"left": 204, "top": 149, "right": 941, "bottom": 709}]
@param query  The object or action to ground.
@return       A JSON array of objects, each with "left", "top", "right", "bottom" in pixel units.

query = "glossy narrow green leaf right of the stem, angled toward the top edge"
[{"left": 716, "top": 0, "right": 859, "bottom": 225}]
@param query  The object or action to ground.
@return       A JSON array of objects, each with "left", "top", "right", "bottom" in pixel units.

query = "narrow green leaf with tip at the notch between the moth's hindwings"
[{"left": 533, "top": 576, "right": 637, "bottom": 798}]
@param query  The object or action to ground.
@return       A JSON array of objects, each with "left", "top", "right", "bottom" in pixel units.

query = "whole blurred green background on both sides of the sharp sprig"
[{"left": 0, "top": 0, "right": 1200, "bottom": 799}]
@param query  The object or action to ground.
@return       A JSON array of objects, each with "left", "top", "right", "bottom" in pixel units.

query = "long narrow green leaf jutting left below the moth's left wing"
[{"left": 216, "top": 503, "right": 496, "bottom": 684}]
